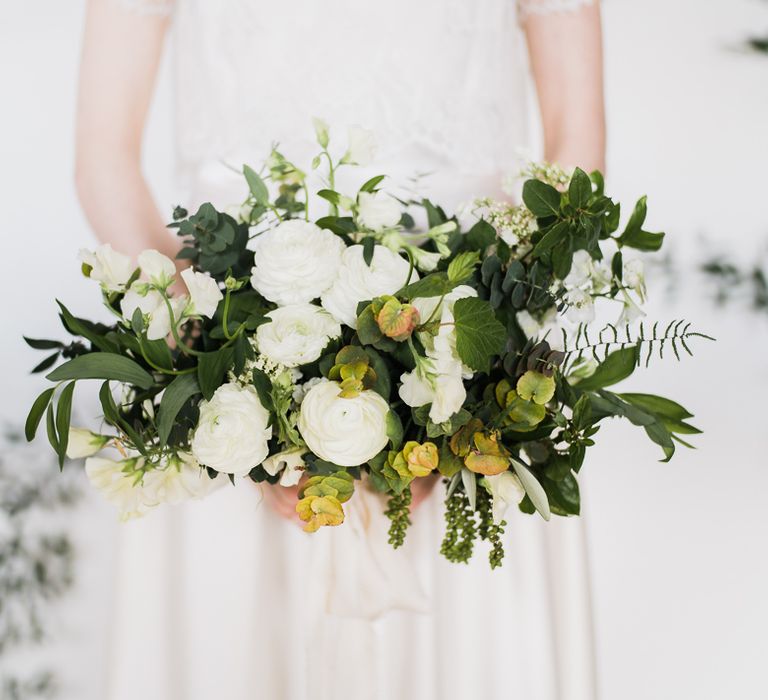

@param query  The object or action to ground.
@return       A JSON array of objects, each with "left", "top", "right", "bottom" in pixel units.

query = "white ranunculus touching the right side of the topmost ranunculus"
[{"left": 321, "top": 245, "right": 419, "bottom": 328}]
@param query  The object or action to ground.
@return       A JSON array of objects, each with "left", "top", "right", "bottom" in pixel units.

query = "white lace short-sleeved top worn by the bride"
[{"left": 118, "top": 0, "right": 593, "bottom": 205}]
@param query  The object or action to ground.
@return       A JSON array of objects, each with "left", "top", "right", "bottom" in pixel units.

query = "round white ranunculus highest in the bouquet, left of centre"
[{"left": 251, "top": 219, "right": 346, "bottom": 306}]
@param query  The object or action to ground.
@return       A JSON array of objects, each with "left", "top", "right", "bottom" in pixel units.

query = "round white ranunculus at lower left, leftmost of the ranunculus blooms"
[{"left": 192, "top": 383, "right": 272, "bottom": 476}]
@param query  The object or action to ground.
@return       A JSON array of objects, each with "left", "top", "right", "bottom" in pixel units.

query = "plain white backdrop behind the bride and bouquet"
[{"left": 0, "top": 0, "right": 768, "bottom": 700}]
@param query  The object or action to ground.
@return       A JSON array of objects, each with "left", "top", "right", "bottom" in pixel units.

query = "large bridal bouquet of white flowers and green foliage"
[{"left": 26, "top": 120, "right": 703, "bottom": 566}]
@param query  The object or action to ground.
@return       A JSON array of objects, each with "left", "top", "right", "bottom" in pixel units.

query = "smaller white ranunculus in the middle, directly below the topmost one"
[{"left": 256, "top": 304, "right": 341, "bottom": 367}]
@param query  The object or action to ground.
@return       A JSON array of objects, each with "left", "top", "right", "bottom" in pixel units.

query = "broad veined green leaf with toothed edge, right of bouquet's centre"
[{"left": 453, "top": 297, "right": 507, "bottom": 372}]
